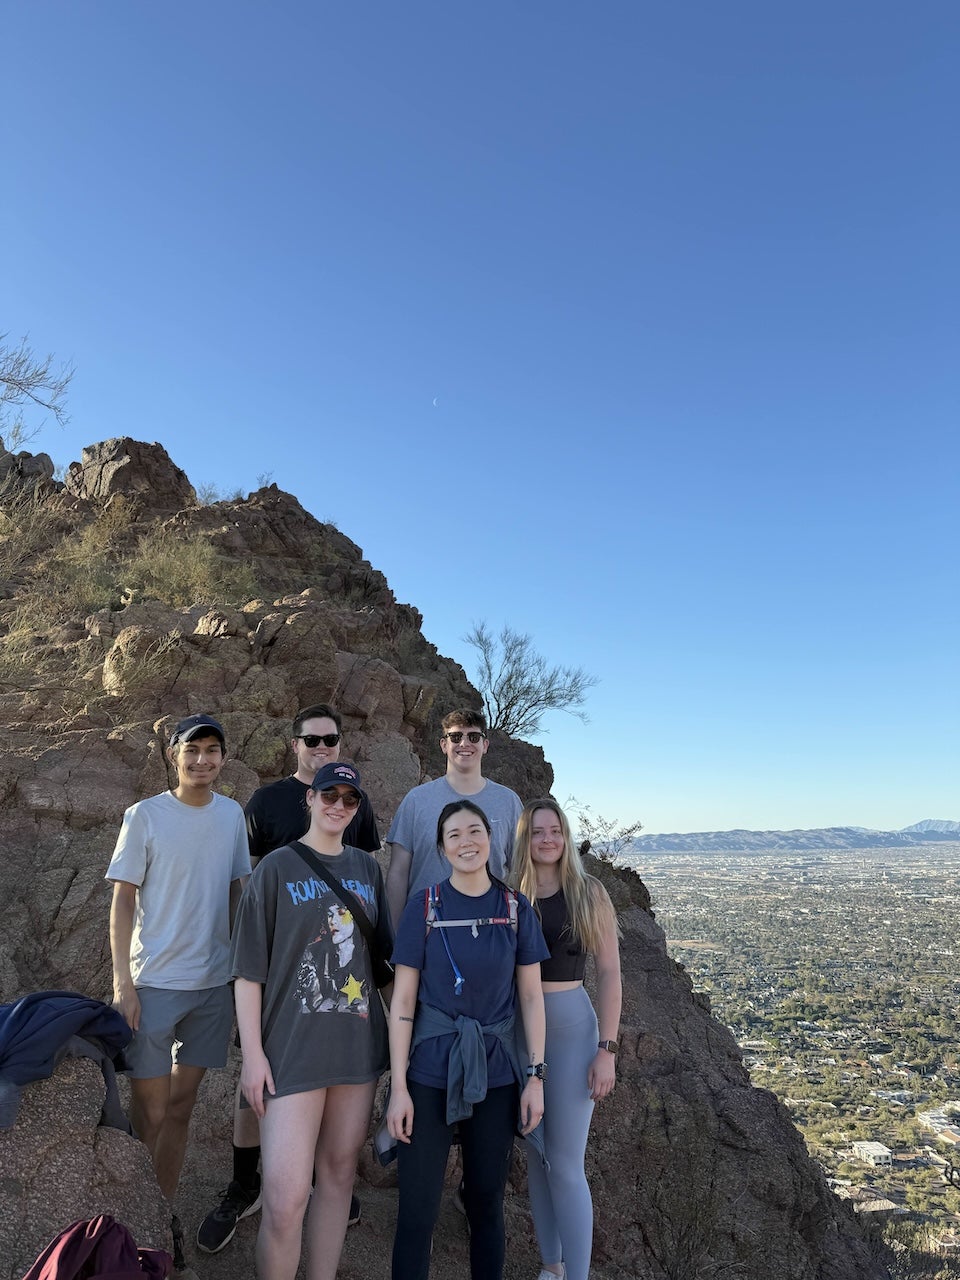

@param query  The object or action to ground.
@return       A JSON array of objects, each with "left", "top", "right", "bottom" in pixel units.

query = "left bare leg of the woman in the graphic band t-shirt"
[{"left": 256, "top": 1089, "right": 325, "bottom": 1280}]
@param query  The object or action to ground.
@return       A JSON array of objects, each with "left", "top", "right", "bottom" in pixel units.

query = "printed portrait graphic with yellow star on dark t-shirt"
[{"left": 287, "top": 879, "right": 371, "bottom": 1018}]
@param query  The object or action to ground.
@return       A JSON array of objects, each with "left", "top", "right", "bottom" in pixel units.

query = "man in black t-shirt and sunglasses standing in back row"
[{"left": 197, "top": 703, "right": 380, "bottom": 1253}]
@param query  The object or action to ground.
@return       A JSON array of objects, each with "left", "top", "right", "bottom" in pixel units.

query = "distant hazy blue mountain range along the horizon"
[{"left": 623, "top": 818, "right": 960, "bottom": 856}]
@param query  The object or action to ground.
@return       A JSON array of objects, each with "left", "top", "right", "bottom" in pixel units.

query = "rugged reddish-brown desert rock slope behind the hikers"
[{"left": 0, "top": 440, "right": 886, "bottom": 1280}]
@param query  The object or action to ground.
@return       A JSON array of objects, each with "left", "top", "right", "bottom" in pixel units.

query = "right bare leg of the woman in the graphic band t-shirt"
[{"left": 307, "top": 1080, "right": 376, "bottom": 1280}]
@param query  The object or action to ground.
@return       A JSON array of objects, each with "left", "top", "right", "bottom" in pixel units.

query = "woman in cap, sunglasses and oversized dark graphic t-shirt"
[{"left": 233, "top": 762, "right": 392, "bottom": 1280}]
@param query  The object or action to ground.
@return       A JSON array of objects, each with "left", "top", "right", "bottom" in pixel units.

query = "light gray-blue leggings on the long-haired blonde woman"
[{"left": 527, "top": 987, "right": 599, "bottom": 1280}]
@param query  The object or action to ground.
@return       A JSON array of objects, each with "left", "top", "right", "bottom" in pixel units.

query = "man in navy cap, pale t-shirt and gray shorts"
[{"left": 106, "top": 716, "right": 250, "bottom": 1213}]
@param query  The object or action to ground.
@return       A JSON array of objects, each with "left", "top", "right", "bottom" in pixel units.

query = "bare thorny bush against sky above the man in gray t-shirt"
[{"left": 463, "top": 622, "right": 596, "bottom": 737}]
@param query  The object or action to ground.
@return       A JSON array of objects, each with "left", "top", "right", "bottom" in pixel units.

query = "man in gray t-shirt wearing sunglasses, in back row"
[{"left": 387, "top": 708, "right": 524, "bottom": 928}]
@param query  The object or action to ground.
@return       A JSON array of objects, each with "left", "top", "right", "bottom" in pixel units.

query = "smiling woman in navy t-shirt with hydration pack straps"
[{"left": 387, "top": 800, "right": 549, "bottom": 1280}]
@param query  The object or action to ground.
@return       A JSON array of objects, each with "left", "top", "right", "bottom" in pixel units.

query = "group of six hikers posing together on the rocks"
[{"left": 106, "top": 704, "right": 621, "bottom": 1280}]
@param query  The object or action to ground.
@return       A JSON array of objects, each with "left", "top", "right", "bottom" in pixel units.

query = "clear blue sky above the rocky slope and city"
[{"left": 0, "top": 0, "right": 960, "bottom": 831}]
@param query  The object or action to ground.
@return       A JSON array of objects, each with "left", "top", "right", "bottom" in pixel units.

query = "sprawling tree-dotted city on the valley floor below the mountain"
[{"left": 622, "top": 842, "right": 960, "bottom": 1253}]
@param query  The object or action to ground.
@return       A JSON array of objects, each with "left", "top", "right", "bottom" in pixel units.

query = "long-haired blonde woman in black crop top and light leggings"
[{"left": 512, "top": 799, "right": 622, "bottom": 1280}]
